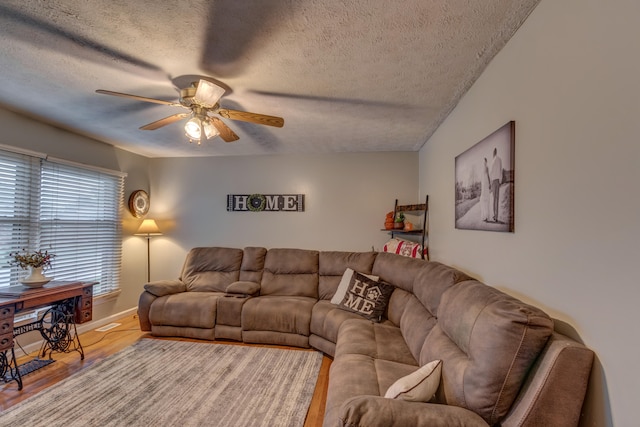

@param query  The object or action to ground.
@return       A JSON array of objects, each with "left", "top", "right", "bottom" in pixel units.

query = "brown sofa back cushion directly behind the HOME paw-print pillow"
[{"left": 318, "top": 251, "right": 377, "bottom": 299}]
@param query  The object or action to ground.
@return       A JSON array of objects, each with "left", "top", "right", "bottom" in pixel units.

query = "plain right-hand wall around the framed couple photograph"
[{"left": 420, "top": 0, "right": 640, "bottom": 426}]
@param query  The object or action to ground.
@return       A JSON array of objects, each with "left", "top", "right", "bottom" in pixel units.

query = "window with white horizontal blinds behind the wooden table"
[{"left": 0, "top": 150, "right": 124, "bottom": 295}]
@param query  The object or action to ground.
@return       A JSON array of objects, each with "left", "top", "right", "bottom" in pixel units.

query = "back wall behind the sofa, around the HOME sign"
[{"left": 149, "top": 153, "right": 419, "bottom": 279}]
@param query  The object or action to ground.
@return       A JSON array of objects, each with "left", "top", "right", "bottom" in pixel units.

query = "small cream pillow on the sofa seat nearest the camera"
[{"left": 384, "top": 360, "right": 442, "bottom": 402}]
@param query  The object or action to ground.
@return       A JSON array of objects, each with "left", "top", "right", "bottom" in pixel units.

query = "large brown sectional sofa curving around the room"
[{"left": 138, "top": 247, "right": 593, "bottom": 426}]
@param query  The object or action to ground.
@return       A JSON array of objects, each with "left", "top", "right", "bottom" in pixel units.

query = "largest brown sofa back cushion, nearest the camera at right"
[{"left": 419, "top": 280, "right": 553, "bottom": 425}]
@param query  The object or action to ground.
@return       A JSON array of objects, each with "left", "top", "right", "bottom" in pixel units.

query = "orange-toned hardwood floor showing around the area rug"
[{"left": 0, "top": 315, "right": 331, "bottom": 427}]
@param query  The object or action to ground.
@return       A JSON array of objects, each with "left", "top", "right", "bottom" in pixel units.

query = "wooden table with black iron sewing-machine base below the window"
[{"left": 0, "top": 281, "right": 97, "bottom": 390}]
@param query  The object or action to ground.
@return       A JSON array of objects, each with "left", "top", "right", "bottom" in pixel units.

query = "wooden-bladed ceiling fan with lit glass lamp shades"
[{"left": 96, "top": 79, "right": 284, "bottom": 144}]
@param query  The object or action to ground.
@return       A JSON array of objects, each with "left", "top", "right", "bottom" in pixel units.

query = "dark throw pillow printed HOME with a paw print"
[{"left": 338, "top": 272, "right": 394, "bottom": 322}]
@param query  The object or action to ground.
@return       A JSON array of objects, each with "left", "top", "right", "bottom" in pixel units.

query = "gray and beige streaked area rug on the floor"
[{"left": 0, "top": 339, "right": 322, "bottom": 427}]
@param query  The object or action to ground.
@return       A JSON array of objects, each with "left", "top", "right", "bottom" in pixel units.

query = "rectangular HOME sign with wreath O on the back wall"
[{"left": 227, "top": 194, "right": 304, "bottom": 212}]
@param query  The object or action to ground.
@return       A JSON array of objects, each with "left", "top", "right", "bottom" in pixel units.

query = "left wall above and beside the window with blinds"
[{"left": 0, "top": 108, "right": 149, "bottom": 322}]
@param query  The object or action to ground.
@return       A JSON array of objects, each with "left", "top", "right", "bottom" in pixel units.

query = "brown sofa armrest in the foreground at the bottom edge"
[{"left": 338, "top": 396, "right": 489, "bottom": 427}]
